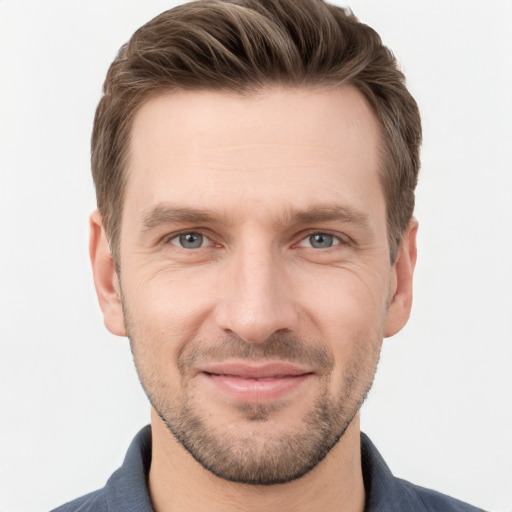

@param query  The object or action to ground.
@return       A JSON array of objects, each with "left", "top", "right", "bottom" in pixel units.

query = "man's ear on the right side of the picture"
[{"left": 384, "top": 219, "right": 418, "bottom": 338}]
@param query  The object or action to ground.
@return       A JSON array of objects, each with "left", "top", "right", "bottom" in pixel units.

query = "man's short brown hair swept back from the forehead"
[{"left": 91, "top": 0, "right": 421, "bottom": 263}]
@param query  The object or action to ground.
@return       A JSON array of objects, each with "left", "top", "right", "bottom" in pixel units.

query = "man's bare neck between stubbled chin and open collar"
[{"left": 148, "top": 410, "right": 365, "bottom": 512}]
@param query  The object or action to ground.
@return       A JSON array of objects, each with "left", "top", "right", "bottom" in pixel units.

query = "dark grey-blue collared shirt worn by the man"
[{"left": 52, "top": 426, "right": 482, "bottom": 512}]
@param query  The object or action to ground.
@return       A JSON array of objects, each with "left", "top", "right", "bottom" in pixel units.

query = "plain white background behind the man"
[{"left": 0, "top": 0, "right": 512, "bottom": 512}]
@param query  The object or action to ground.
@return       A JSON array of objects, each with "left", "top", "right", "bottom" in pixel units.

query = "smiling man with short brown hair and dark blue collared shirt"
[{"left": 56, "top": 0, "right": 486, "bottom": 512}]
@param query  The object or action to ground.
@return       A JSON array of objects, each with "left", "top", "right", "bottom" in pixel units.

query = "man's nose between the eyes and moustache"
[{"left": 216, "top": 241, "right": 298, "bottom": 343}]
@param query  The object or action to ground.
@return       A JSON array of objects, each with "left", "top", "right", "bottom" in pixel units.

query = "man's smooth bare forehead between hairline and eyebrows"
[{"left": 123, "top": 87, "right": 383, "bottom": 228}]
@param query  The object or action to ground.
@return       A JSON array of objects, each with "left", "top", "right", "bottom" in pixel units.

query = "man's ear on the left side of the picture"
[{"left": 89, "top": 210, "right": 126, "bottom": 336}]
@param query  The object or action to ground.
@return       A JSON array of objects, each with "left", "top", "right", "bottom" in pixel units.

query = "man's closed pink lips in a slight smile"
[{"left": 199, "top": 362, "right": 314, "bottom": 403}]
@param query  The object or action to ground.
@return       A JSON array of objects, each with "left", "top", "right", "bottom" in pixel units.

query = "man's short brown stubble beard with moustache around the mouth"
[{"left": 125, "top": 316, "right": 380, "bottom": 485}]
